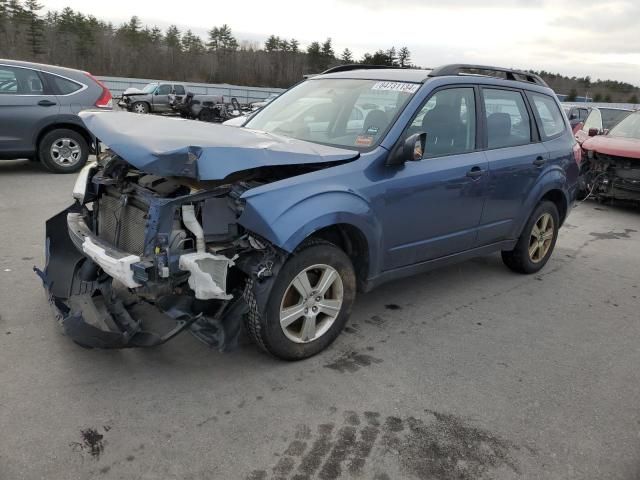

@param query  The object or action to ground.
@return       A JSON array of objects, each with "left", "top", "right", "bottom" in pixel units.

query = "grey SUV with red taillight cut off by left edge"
[{"left": 0, "top": 60, "right": 112, "bottom": 173}]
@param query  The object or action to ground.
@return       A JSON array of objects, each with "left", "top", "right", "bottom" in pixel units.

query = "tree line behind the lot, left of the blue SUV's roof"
[{"left": 0, "top": 0, "right": 412, "bottom": 87}]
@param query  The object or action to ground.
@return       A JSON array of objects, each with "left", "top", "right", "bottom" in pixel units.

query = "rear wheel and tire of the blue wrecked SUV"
[{"left": 502, "top": 200, "right": 560, "bottom": 274}]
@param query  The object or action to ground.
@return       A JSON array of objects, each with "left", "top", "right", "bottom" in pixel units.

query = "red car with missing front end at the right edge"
[{"left": 580, "top": 110, "right": 640, "bottom": 202}]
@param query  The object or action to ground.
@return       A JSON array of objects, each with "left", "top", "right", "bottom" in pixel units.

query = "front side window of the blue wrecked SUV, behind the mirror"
[{"left": 408, "top": 87, "right": 476, "bottom": 158}]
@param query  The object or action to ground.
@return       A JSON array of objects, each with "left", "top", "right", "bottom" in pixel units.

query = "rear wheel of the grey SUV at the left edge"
[{"left": 38, "top": 128, "right": 89, "bottom": 173}]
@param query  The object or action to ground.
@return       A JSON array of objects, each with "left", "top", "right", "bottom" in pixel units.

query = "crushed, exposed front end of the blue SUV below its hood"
[{"left": 36, "top": 151, "right": 282, "bottom": 350}]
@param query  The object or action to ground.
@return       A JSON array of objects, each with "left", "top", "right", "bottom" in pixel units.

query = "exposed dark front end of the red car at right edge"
[{"left": 581, "top": 150, "right": 640, "bottom": 201}]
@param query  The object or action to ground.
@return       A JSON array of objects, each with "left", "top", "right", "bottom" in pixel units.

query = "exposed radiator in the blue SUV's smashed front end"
[{"left": 98, "top": 193, "right": 147, "bottom": 255}]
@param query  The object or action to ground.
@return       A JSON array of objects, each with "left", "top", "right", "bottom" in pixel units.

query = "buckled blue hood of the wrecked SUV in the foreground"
[{"left": 80, "top": 111, "right": 359, "bottom": 180}]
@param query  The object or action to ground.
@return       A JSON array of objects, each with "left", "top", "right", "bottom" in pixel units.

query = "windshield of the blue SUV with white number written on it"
[{"left": 245, "top": 79, "right": 420, "bottom": 149}]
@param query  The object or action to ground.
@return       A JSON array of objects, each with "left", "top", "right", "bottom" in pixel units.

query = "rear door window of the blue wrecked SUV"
[{"left": 482, "top": 88, "right": 531, "bottom": 148}]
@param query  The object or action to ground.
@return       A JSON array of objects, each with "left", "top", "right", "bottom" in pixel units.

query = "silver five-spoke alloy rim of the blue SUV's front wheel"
[{"left": 280, "top": 264, "right": 344, "bottom": 343}]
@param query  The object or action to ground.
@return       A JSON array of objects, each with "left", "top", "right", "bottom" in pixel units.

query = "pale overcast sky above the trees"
[{"left": 41, "top": 0, "right": 640, "bottom": 85}]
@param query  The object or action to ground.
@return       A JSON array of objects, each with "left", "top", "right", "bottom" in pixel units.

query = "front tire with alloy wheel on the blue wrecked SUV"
[{"left": 247, "top": 241, "right": 356, "bottom": 360}]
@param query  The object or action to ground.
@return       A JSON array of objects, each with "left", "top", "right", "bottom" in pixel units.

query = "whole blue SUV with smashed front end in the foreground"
[{"left": 39, "top": 65, "right": 581, "bottom": 359}]
